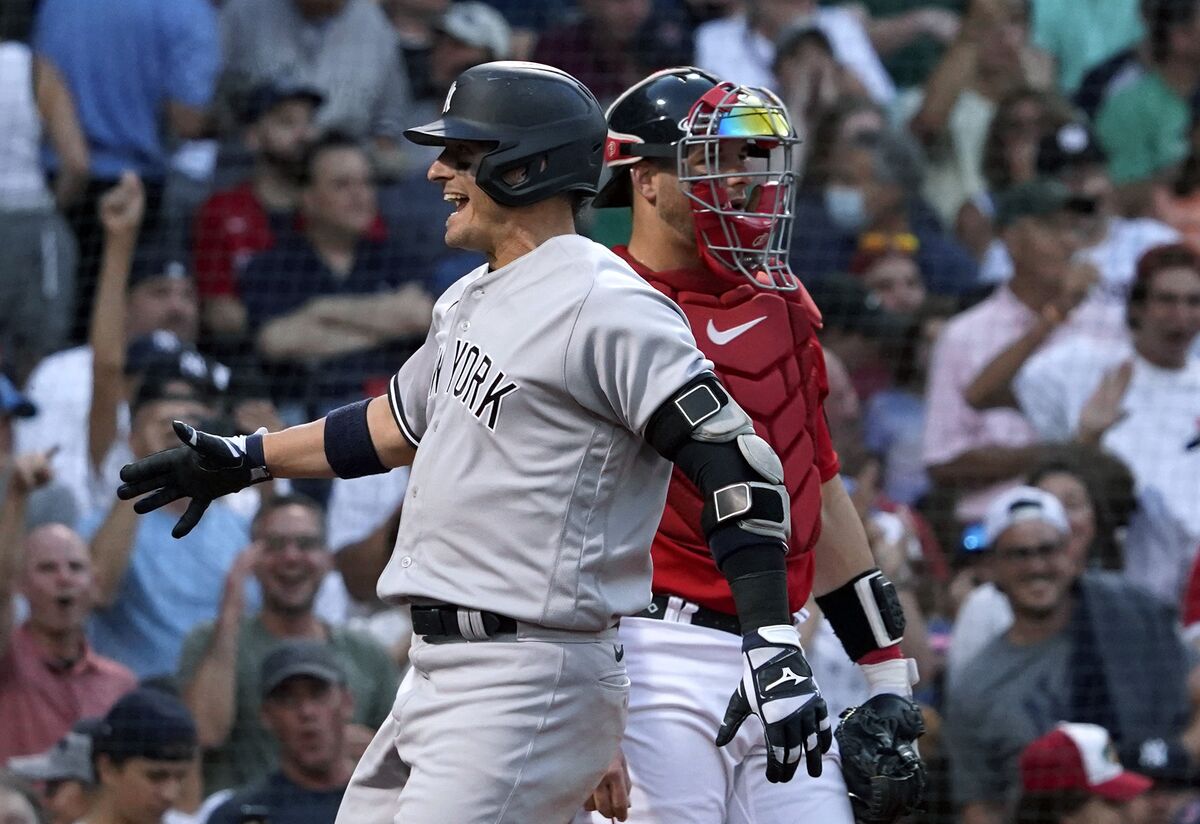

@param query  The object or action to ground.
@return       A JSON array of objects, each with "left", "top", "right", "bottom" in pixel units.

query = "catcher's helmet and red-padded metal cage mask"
[{"left": 596, "top": 68, "right": 799, "bottom": 290}]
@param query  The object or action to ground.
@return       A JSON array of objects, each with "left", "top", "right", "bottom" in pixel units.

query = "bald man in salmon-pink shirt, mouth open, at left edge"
[{"left": 0, "top": 453, "right": 136, "bottom": 763}]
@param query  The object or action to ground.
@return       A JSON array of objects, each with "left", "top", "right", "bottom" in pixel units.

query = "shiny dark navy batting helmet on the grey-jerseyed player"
[{"left": 404, "top": 60, "right": 607, "bottom": 206}]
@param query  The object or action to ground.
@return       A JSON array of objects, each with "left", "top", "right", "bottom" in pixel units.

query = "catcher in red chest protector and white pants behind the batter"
[{"left": 589, "top": 67, "right": 924, "bottom": 824}]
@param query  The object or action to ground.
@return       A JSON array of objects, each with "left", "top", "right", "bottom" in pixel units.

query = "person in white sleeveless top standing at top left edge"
[{"left": 0, "top": 0, "right": 88, "bottom": 380}]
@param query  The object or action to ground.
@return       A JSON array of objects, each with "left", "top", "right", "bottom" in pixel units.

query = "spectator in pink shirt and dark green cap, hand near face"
[{"left": 923, "top": 180, "right": 1124, "bottom": 523}]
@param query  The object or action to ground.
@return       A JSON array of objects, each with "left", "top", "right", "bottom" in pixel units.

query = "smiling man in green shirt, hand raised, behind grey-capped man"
[{"left": 180, "top": 495, "right": 400, "bottom": 793}]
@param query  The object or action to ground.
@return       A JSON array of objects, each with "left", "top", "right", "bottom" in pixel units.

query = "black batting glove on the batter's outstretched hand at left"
[{"left": 116, "top": 421, "right": 271, "bottom": 537}]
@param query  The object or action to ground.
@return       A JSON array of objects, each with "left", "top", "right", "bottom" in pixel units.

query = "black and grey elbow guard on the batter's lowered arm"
[{"left": 646, "top": 374, "right": 792, "bottom": 566}]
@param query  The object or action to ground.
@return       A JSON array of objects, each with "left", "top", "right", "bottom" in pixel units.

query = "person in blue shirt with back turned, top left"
[{"left": 34, "top": 0, "right": 221, "bottom": 341}]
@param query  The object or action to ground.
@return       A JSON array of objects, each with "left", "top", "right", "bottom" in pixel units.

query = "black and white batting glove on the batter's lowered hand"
[{"left": 716, "top": 625, "right": 833, "bottom": 783}]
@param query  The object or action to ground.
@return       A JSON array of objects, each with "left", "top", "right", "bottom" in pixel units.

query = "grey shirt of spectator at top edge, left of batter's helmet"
[{"left": 221, "top": 0, "right": 412, "bottom": 151}]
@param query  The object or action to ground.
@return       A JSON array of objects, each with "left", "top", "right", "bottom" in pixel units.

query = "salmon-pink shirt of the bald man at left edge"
[{"left": 0, "top": 626, "right": 138, "bottom": 764}]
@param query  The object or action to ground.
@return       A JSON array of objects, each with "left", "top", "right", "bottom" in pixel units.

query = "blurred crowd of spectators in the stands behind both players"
[{"left": 0, "top": 0, "right": 1200, "bottom": 824}]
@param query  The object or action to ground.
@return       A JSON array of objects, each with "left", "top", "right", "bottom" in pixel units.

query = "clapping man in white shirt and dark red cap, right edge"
[{"left": 1013, "top": 245, "right": 1200, "bottom": 603}]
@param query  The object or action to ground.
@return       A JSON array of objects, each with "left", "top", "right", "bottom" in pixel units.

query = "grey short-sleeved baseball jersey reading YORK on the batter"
[{"left": 378, "top": 235, "right": 712, "bottom": 631}]
